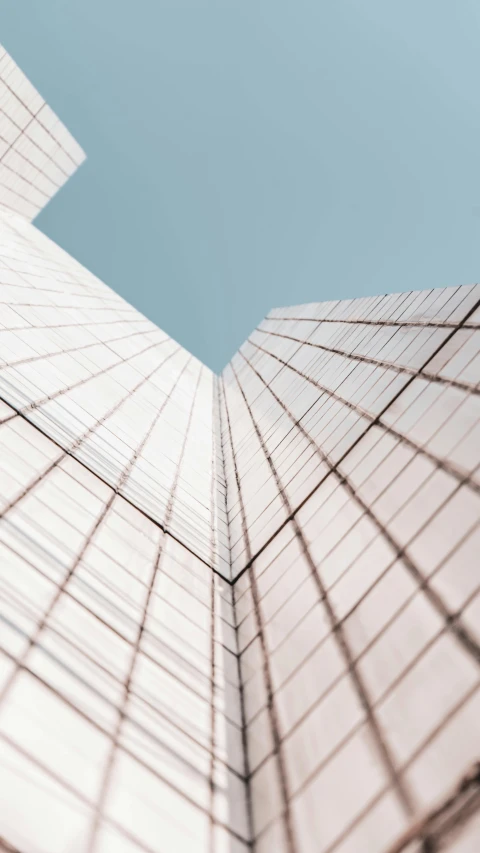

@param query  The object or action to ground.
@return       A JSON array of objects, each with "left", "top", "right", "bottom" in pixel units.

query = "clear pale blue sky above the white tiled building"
[{"left": 0, "top": 0, "right": 480, "bottom": 370}]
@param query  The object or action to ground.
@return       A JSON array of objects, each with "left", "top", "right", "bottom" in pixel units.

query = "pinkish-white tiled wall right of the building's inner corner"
[{"left": 222, "top": 286, "right": 480, "bottom": 853}]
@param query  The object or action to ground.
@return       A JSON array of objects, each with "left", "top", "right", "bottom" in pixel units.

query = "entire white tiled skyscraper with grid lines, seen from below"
[{"left": 0, "top": 45, "right": 480, "bottom": 853}]
